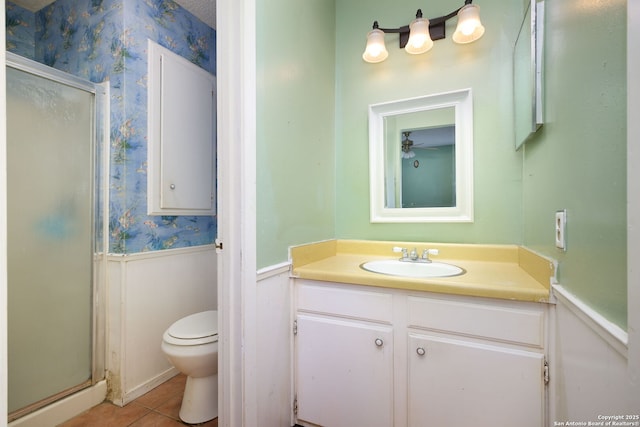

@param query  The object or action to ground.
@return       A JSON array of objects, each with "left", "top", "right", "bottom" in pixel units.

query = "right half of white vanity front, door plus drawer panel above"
[{"left": 407, "top": 296, "right": 546, "bottom": 427}]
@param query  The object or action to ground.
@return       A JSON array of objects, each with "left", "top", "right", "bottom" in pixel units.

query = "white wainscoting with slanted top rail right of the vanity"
[{"left": 549, "top": 286, "right": 637, "bottom": 426}]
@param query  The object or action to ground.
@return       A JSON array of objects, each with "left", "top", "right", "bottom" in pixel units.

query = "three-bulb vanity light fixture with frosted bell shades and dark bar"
[{"left": 362, "top": 0, "right": 484, "bottom": 64}]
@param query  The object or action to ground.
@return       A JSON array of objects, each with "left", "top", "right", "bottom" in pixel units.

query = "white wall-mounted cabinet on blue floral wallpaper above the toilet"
[{"left": 147, "top": 40, "right": 216, "bottom": 215}]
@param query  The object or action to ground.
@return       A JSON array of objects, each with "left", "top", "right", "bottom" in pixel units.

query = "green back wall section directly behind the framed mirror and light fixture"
[{"left": 336, "top": 0, "right": 523, "bottom": 243}]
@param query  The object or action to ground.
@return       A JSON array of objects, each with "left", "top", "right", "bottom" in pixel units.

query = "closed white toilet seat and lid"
[{"left": 163, "top": 310, "right": 218, "bottom": 346}]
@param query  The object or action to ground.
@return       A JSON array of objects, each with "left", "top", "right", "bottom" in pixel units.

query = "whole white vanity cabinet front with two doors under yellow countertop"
[{"left": 294, "top": 280, "right": 547, "bottom": 427}]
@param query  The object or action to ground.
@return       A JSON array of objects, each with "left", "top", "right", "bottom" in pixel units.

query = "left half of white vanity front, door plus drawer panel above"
[{"left": 296, "top": 283, "right": 394, "bottom": 427}]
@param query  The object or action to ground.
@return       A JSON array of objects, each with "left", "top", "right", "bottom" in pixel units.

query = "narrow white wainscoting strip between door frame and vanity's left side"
[{"left": 256, "top": 263, "right": 293, "bottom": 427}]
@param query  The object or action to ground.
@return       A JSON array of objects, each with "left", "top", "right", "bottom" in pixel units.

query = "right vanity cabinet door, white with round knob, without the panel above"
[{"left": 407, "top": 333, "right": 544, "bottom": 427}]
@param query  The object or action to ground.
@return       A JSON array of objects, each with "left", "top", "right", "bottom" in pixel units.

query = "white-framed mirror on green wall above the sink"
[{"left": 369, "top": 89, "right": 473, "bottom": 226}]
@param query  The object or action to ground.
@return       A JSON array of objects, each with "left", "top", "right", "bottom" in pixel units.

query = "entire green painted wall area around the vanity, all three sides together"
[{"left": 257, "top": 0, "right": 627, "bottom": 328}]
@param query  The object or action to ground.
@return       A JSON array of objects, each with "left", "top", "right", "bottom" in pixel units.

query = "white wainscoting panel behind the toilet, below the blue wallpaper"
[{"left": 106, "top": 245, "right": 217, "bottom": 405}]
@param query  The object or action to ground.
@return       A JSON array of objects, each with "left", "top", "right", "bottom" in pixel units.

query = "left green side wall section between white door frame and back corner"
[{"left": 256, "top": 0, "right": 335, "bottom": 268}]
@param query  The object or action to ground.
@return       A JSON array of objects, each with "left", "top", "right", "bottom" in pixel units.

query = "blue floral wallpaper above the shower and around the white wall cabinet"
[{"left": 7, "top": 0, "right": 217, "bottom": 253}]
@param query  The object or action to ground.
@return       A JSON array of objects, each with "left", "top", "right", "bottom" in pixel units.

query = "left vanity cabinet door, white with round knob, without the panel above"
[{"left": 295, "top": 313, "right": 393, "bottom": 427}]
